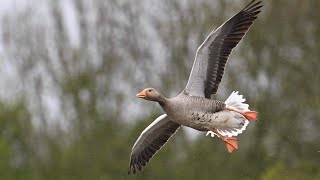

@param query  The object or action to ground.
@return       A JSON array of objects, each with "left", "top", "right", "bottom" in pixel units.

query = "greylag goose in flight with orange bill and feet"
[{"left": 128, "top": 0, "right": 262, "bottom": 174}]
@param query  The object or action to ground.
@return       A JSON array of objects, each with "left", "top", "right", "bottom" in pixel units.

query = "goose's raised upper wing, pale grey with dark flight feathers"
[{"left": 185, "top": 0, "right": 262, "bottom": 99}]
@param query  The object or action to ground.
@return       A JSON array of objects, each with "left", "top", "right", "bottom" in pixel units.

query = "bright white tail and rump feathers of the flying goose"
[{"left": 206, "top": 91, "right": 249, "bottom": 137}]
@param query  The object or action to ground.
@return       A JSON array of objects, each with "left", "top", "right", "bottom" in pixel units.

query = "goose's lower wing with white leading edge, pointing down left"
[{"left": 128, "top": 114, "right": 180, "bottom": 174}]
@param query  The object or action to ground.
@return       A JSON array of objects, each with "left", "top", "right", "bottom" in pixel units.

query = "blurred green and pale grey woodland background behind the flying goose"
[{"left": 0, "top": 0, "right": 320, "bottom": 180}]
